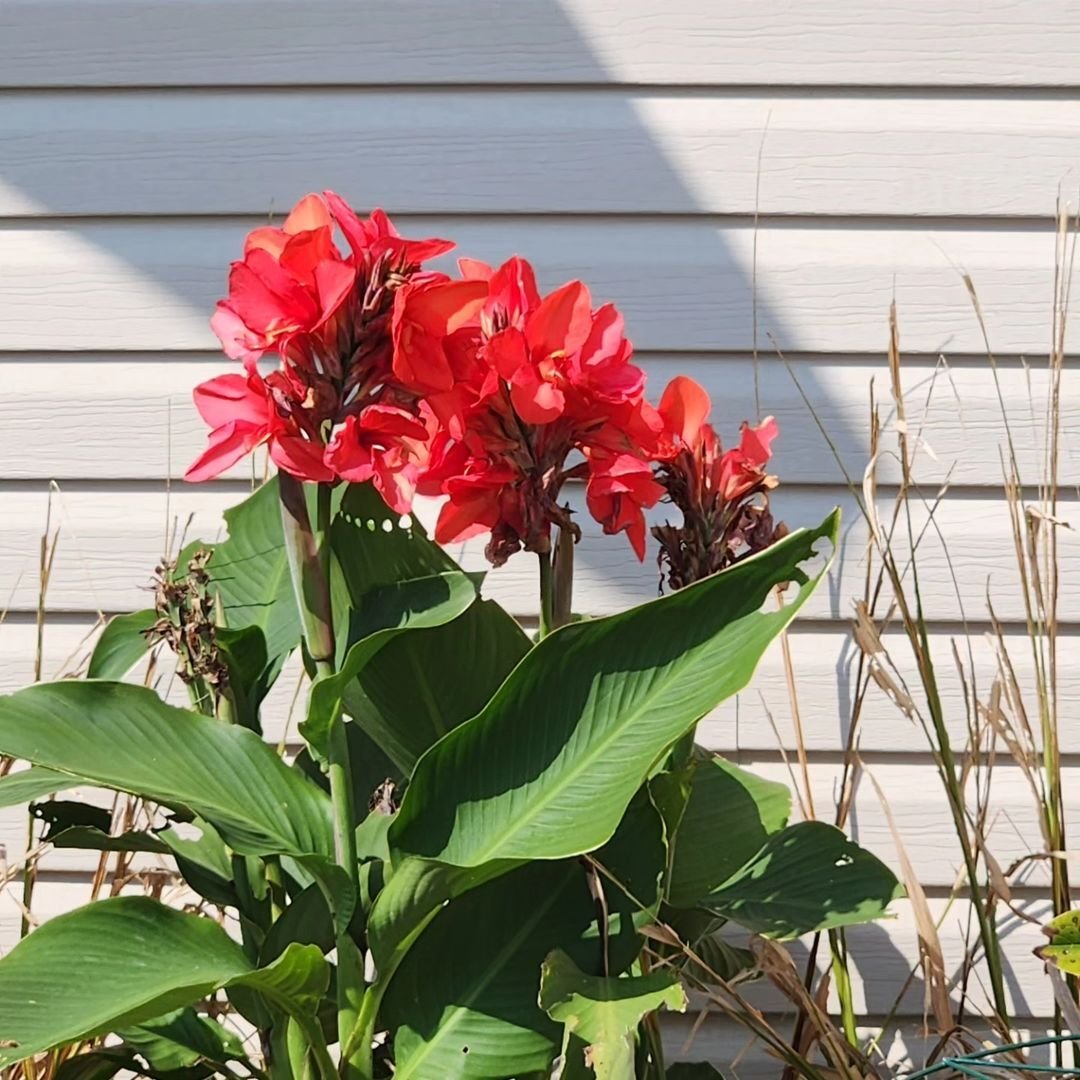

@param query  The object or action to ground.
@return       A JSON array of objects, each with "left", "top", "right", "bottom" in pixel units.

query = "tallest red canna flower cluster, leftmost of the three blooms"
[{"left": 187, "top": 191, "right": 454, "bottom": 512}]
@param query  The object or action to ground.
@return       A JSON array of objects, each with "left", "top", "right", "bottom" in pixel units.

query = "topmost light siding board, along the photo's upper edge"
[{"left": 0, "top": 0, "right": 1080, "bottom": 86}]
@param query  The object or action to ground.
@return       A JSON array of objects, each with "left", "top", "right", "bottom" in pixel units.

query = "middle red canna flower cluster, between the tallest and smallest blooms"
[{"left": 393, "top": 258, "right": 663, "bottom": 566}]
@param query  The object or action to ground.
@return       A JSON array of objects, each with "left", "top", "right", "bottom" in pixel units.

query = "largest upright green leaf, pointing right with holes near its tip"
[{"left": 391, "top": 513, "right": 838, "bottom": 866}]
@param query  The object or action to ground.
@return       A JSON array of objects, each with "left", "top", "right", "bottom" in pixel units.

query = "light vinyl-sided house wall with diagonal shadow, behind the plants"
[{"left": 0, "top": 0, "right": 1080, "bottom": 1077}]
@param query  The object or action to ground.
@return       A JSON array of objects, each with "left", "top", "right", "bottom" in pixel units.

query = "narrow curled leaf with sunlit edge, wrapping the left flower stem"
[{"left": 300, "top": 570, "right": 476, "bottom": 760}]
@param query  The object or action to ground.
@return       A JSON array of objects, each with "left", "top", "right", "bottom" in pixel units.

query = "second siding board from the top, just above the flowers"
[{"left": 0, "top": 93, "right": 1080, "bottom": 216}]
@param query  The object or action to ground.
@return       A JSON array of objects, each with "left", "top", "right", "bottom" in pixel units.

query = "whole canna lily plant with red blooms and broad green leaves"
[{"left": 0, "top": 192, "right": 897, "bottom": 1080}]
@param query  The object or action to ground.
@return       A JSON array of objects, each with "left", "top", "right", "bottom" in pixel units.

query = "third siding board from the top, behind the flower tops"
[{"left": 0, "top": 218, "right": 1077, "bottom": 354}]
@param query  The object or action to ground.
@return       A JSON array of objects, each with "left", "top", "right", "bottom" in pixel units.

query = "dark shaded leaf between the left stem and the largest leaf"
[{"left": 345, "top": 599, "right": 530, "bottom": 775}]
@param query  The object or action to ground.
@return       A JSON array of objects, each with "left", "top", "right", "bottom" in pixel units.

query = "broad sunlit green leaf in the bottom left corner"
[{"left": 0, "top": 896, "right": 329, "bottom": 1067}]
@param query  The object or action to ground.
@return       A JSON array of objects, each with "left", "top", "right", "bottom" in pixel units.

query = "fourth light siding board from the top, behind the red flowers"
[{"left": 0, "top": 352, "right": 1080, "bottom": 486}]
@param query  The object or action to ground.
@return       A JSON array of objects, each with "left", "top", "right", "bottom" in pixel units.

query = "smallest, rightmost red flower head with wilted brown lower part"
[{"left": 652, "top": 375, "right": 787, "bottom": 589}]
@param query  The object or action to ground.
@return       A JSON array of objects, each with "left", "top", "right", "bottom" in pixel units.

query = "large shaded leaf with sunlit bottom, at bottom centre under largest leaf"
[{"left": 382, "top": 860, "right": 639, "bottom": 1080}]
